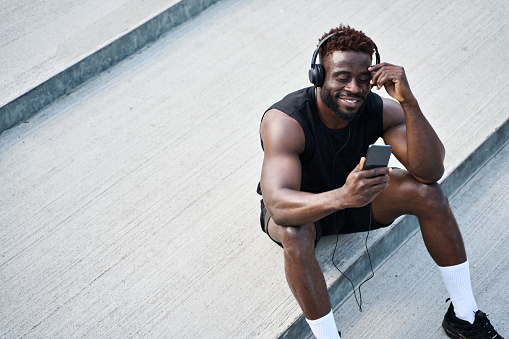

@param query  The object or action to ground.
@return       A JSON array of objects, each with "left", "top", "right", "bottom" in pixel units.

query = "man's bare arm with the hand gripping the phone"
[{"left": 260, "top": 110, "right": 390, "bottom": 226}]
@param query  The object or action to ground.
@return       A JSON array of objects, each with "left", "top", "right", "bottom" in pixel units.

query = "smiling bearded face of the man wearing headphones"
[{"left": 320, "top": 51, "right": 371, "bottom": 121}]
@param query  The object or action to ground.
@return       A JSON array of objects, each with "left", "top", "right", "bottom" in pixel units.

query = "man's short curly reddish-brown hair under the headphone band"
[{"left": 319, "top": 24, "right": 375, "bottom": 62}]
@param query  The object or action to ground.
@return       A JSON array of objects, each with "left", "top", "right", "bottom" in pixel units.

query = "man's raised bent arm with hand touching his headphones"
[{"left": 369, "top": 63, "right": 445, "bottom": 183}]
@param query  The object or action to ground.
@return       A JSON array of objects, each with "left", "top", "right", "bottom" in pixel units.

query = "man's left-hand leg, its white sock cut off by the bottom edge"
[{"left": 268, "top": 219, "right": 339, "bottom": 338}]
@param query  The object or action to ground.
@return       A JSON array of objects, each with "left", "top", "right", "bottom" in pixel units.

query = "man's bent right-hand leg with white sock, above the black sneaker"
[{"left": 373, "top": 170, "right": 477, "bottom": 322}]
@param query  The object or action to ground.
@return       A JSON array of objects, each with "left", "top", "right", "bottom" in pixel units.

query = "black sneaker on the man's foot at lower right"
[{"left": 442, "top": 303, "right": 504, "bottom": 339}]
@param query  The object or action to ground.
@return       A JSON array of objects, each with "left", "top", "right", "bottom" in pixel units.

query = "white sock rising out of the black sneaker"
[{"left": 438, "top": 260, "right": 478, "bottom": 324}]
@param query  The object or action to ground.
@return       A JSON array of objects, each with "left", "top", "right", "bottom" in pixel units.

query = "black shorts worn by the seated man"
[{"left": 260, "top": 199, "right": 392, "bottom": 247}]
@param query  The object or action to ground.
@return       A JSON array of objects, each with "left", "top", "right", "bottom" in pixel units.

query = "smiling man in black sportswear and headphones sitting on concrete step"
[{"left": 259, "top": 25, "right": 501, "bottom": 338}]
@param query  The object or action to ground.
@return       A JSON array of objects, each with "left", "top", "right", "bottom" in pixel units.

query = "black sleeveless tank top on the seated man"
[{"left": 258, "top": 87, "right": 383, "bottom": 194}]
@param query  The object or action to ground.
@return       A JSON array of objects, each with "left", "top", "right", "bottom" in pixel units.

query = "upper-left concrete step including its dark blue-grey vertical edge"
[{"left": 0, "top": 0, "right": 217, "bottom": 133}]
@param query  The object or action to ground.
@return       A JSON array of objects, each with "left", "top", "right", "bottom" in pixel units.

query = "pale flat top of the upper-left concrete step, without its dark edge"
[{"left": 0, "top": 0, "right": 178, "bottom": 106}]
